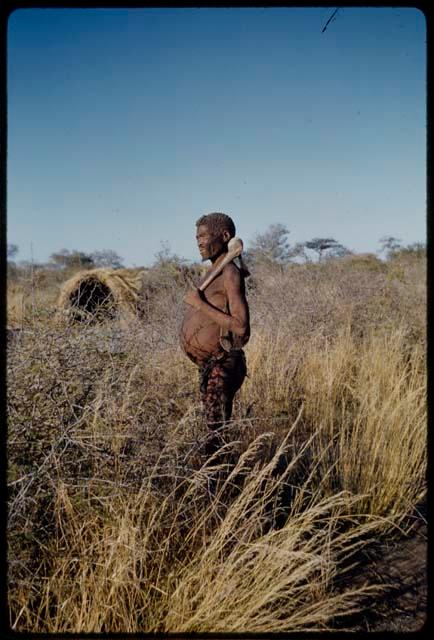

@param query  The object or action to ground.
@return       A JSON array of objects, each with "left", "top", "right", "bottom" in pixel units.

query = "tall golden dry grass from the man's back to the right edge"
[{"left": 243, "top": 327, "right": 427, "bottom": 525}]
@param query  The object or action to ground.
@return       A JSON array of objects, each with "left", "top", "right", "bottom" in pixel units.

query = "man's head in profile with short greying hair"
[{"left": 196, "top": 212, "right": 235, "bottom": 260}]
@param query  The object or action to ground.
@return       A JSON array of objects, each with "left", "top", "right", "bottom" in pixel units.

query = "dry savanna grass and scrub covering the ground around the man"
[{"left": 7, "top": 228, "right": 426, "bottom": 633}]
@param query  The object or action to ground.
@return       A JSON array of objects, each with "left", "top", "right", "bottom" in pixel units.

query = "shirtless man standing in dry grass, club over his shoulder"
[{"left": 181, "top": 213, "right": 250, "bottom": 455}]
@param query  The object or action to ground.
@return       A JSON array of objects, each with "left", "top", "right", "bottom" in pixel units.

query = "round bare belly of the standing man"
[{"left": 180, "top": 308, "right": 222, "bottom": 364}]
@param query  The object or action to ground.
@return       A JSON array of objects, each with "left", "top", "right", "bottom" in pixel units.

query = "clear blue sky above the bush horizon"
[{"left": 7, "top": 8, "right": 426, "bottom": 266}]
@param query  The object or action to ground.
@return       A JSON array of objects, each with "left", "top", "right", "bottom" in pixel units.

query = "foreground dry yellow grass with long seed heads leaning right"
[{"left": 13, "top": 420, "right": 386, "bottom": 633}]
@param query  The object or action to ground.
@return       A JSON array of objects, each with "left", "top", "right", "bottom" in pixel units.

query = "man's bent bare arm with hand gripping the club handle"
[{"left": 184, "top": 263, "right": 249, "bottom": 337}]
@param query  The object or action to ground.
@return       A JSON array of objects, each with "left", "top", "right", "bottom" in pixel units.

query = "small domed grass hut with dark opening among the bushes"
[{"left": 57, "top": 268, "right": 145, "bottom": 322}]
